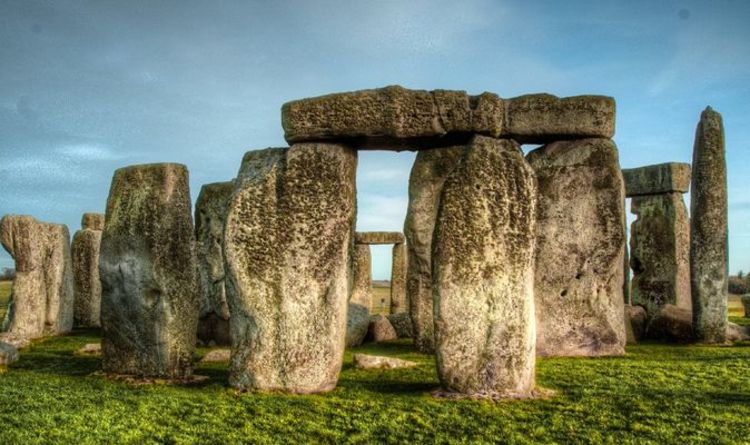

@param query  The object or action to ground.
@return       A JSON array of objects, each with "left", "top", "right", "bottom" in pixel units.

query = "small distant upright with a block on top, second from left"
[{"left": 70, "top": 213, "right": 104, "bottom": 328}]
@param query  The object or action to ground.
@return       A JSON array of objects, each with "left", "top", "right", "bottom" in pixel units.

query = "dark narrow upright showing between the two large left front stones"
[{"left": 195, "top": 181, "right": 234, "bottom": 345}]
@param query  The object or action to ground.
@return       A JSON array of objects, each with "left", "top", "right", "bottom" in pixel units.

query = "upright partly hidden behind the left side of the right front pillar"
[{"left": 404, "top": 146, "right": 466, "bottom": 353}]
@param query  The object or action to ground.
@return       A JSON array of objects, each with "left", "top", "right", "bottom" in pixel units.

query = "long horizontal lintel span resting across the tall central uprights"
[{"left": 281, "top": 85, "right": 615, "bottom": 151}]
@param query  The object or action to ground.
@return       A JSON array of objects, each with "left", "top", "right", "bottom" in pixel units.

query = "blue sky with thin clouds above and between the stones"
[{"left": 0, "top": 0, "right": 750, "bottom": 278}]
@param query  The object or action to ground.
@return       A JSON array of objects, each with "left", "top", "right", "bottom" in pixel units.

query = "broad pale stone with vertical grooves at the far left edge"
[{"left": 0, "top": 215, "right": 74, "bottom": 343}]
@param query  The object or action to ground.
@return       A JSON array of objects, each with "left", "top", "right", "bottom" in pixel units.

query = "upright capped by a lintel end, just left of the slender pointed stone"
[{"left": 622, "top": 163, "right": 692, "bottom": 316}]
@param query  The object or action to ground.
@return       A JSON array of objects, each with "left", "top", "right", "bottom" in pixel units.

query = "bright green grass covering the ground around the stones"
[{"left": 0, "top": 331, "right": 750, "bottom": 444}]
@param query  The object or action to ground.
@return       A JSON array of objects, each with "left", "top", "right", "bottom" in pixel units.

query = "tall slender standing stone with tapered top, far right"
[{"left": 690, "top": 107, "right": 729, "bottom": 343}]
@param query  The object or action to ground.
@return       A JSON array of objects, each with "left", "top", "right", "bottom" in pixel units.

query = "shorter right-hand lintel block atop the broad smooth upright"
[{"left": 503, "top": 94, "right": 615, "bottom": 144}]
